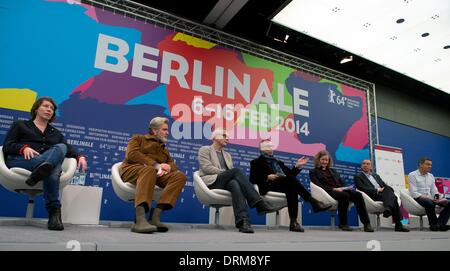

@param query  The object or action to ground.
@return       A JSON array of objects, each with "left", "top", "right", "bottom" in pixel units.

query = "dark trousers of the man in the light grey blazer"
[{"left": 208, "top": 168, "right": 262, "bottom": 225}]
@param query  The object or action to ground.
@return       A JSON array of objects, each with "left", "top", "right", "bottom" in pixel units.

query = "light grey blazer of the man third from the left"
[{"left": 198, "top": 145, "right": 233, "bottom": 186}]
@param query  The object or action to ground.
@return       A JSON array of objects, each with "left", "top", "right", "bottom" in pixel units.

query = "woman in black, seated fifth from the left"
[{"left": 309, "top": 150, "right": 373, "bottom": 232}]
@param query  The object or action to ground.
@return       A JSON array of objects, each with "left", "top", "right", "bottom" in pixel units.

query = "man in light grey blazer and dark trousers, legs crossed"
[{"left": 198, "top": 129, "right": 276, "bottom": 233}]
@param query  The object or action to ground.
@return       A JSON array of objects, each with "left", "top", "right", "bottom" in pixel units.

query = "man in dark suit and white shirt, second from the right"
[{"left": 355, "top": 159, "right": 409, "bottom": 232}]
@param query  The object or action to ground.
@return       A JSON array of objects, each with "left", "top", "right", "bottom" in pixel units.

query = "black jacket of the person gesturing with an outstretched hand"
[{"left": 250, "top": 155, "right": 301, "bottom": 195}]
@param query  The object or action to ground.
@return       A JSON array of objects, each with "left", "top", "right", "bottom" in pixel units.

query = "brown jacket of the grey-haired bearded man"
[{"left": 119, "top": 134, "right": 177, "bottom": 175}]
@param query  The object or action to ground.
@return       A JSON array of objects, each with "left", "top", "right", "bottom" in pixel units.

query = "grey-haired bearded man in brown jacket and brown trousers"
[{"left": 119, "top": 117, "right": 186, "bottom": 233}]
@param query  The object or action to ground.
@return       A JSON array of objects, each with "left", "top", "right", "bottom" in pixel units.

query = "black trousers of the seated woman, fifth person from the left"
[{"left": 328, "top": 190, "right": 370, "bottom": 225}]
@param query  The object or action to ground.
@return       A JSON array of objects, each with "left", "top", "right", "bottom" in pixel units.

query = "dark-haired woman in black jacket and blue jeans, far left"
[{"left": 3, "top": 97, "right": 87, "bottom": 231}]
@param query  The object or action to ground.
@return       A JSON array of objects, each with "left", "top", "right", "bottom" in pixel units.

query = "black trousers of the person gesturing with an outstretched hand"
[{"left": 269, "top": 176, "right": 311, "bottom": 219}]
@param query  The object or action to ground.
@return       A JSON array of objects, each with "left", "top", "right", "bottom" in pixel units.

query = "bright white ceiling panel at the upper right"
[{"left": 272, "top": 0, "right": 450, "bottom": 94}]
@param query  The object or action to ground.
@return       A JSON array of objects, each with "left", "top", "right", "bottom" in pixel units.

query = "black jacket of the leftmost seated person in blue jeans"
[{"left": 3, "top": 120, "right": 81, "bottom": 158}]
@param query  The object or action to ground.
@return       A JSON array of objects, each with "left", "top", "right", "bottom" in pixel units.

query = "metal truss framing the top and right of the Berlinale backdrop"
[{"left": 81, "top": 0, "right": 378, "bottom": 160}]
